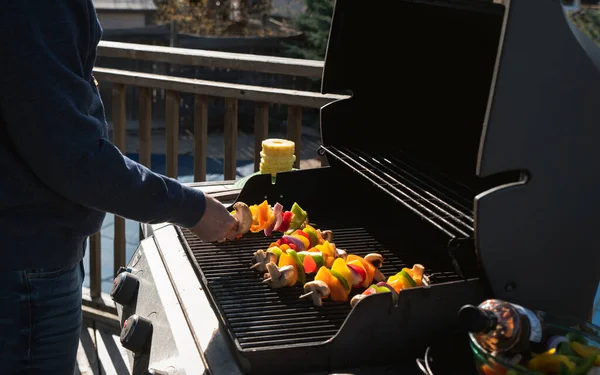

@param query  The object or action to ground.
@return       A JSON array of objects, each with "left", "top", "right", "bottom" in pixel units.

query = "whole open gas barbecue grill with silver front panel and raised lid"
[{"left": 113, "top": 0, "right": 600, "bottom": 374}]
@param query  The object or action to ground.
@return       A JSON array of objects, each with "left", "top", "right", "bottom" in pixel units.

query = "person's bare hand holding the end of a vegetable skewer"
[{"left": 189, "top": 194, "right": 238, "bottom": 242}]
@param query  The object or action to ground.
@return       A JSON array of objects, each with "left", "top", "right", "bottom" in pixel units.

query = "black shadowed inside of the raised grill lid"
[{"left": 321, "top": 0, "right": 504, "bottom": 195}]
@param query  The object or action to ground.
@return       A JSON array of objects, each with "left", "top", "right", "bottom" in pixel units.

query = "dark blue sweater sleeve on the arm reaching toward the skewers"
[{"left": 0, "top": 0, "right": 206, "bottom": 227}]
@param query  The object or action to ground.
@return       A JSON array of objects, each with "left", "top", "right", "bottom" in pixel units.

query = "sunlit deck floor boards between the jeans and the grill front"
[{"left": 75, "top": 326, "right": 131, "bottom": 375}]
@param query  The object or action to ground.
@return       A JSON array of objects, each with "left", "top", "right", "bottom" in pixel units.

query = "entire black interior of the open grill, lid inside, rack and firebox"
[{"left": 172, "top": 0, "right": 519, "bottom": 374}]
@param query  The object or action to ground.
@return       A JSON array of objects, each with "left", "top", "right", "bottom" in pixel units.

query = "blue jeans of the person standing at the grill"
[{"left": 0, "top": 262, "right": 84, "bottom": 375}]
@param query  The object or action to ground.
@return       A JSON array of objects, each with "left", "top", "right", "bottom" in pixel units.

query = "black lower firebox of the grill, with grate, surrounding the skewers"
[{"left": 180, "top": 167, "right": 484, "bottom": 374}]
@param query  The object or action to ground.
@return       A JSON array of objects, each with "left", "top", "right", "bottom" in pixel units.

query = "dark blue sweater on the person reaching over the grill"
[{"left": 0, "top": 0, "right": 205, "bottom": 269}]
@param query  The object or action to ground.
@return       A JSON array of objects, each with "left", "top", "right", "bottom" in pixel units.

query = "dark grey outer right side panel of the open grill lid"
[{"left": 475, "top": 0, "right": 600, "bottom": 319}]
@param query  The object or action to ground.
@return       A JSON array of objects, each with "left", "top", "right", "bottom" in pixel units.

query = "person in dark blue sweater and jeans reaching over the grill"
[{"left": 0, "top": 0, "right": 237, "bottom": 375}]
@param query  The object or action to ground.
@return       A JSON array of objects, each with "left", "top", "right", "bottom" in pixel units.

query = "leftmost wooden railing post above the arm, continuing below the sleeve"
[{"left": 112, "top": 84, "right": 127, "bottom": 276}]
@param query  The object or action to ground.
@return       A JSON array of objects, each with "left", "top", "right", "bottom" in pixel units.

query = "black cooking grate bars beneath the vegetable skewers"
[{"left": 176, "top": 223, "right": 459, "bottom": 350}]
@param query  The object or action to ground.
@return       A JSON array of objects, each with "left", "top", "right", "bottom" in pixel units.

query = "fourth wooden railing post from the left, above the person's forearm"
[{"left": 194, "top": 95, "right": 208, "bottom": 182}]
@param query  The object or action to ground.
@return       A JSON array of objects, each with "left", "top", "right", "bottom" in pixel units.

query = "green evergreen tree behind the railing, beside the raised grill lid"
[{"left": 286, "top": 0, "right": 335, "bottom": 60}]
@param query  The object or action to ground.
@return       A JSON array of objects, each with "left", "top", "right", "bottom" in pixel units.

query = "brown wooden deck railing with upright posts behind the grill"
[{"left": 84, "top": 41, "right": 345, "bottom": 298}]
